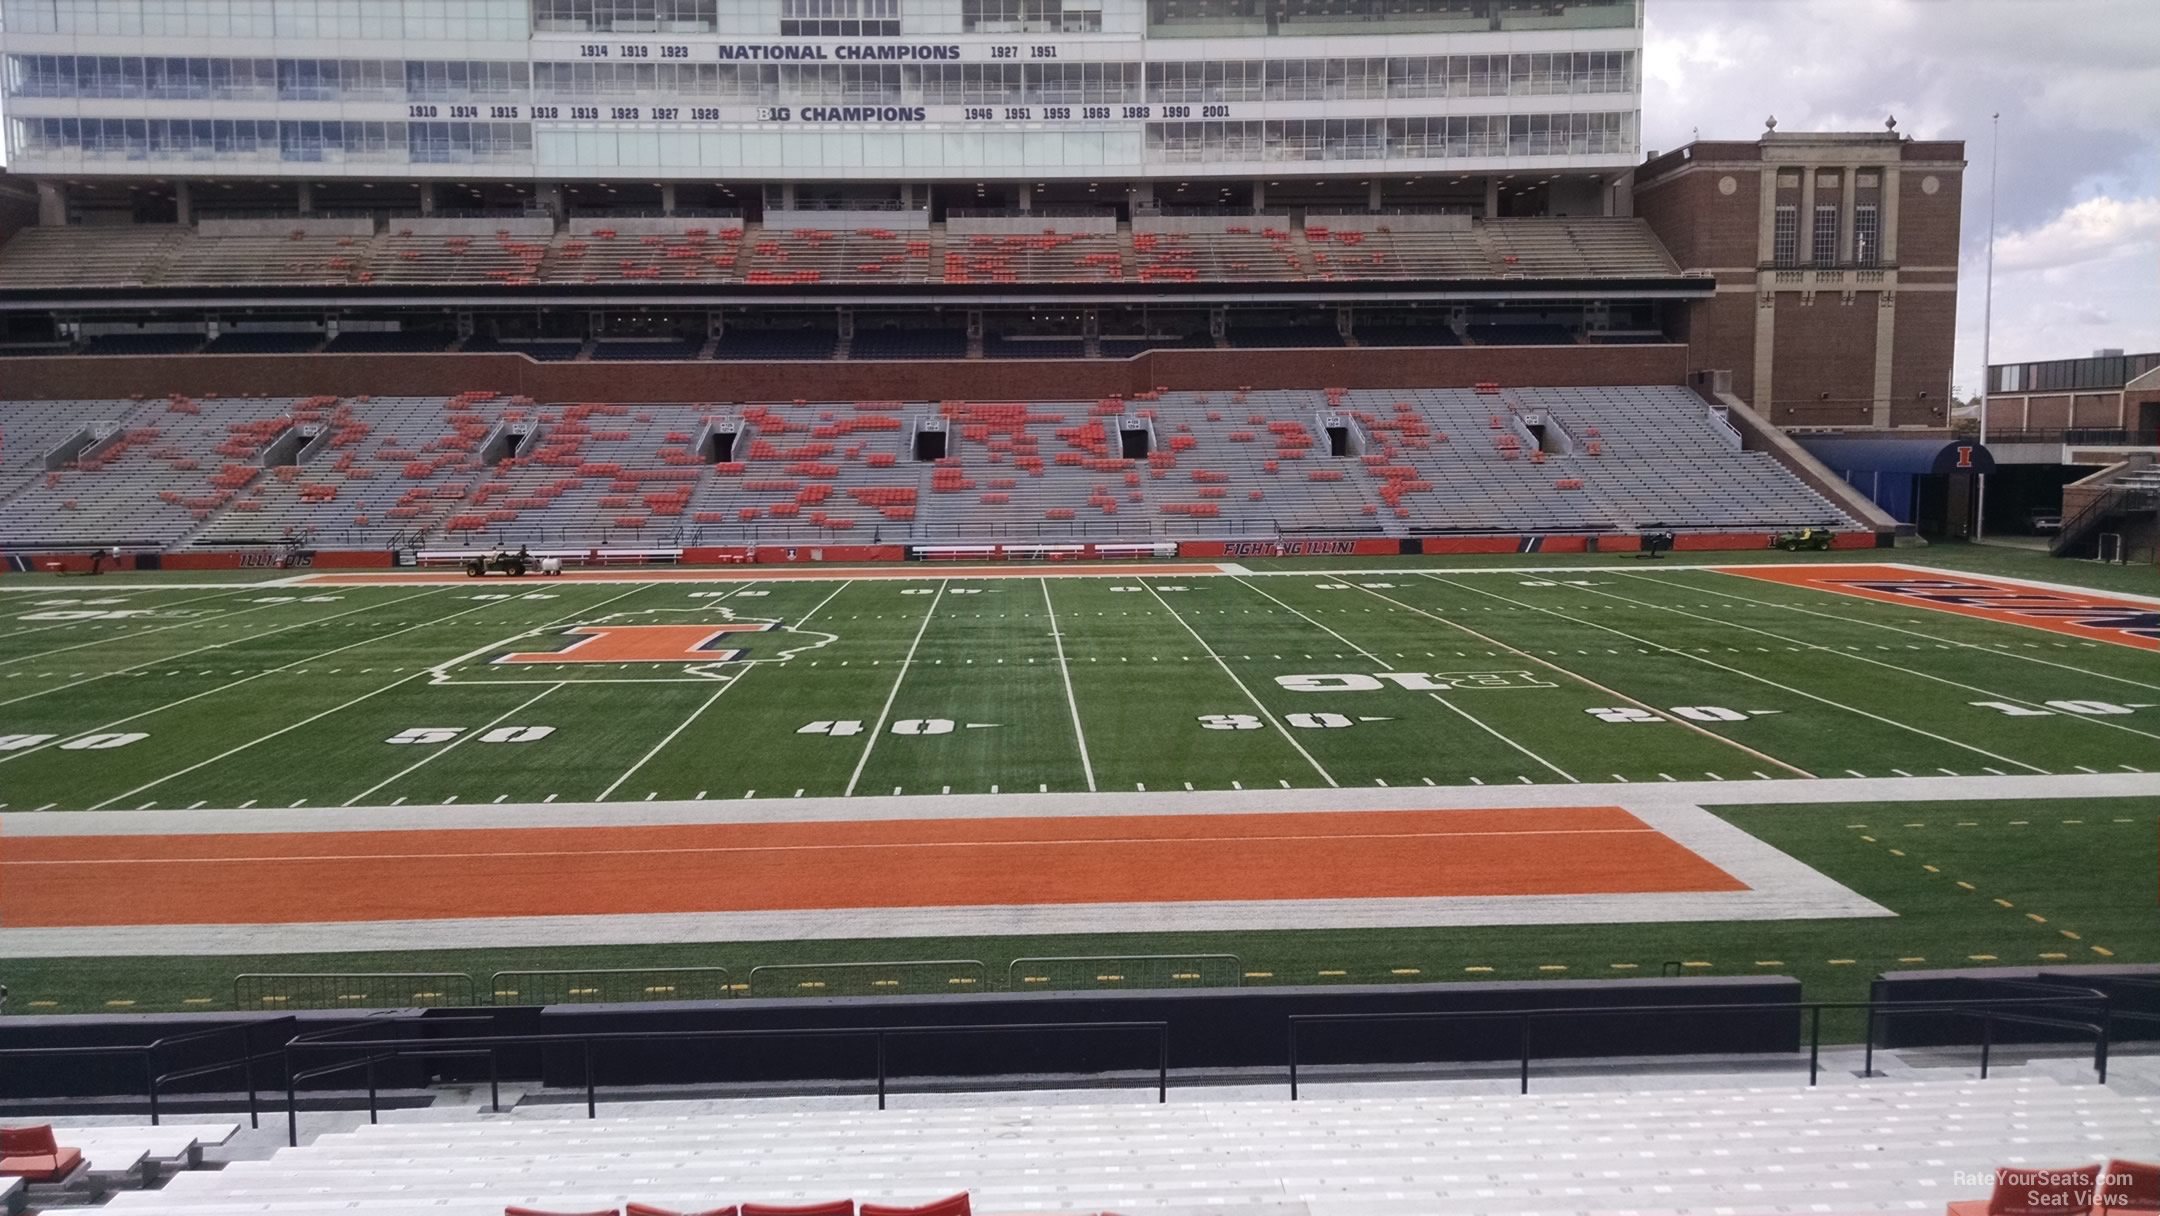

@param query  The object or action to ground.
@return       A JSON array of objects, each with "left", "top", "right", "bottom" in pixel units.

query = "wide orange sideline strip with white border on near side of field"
[{"left": 0, "top": 808, "right": 1745, "bottom": 929}]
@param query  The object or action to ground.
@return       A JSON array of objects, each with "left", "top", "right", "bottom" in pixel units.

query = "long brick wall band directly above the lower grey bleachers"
[{"left": 0, "top": 346, "right": 1687, "bottom": 402}]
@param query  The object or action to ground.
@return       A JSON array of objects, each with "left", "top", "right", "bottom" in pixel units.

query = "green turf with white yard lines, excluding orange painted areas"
[{"left": 0, "top": 551, "right": 2160, "bottom": 1013}]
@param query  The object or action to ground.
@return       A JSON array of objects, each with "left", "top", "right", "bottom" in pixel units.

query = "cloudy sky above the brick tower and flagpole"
[{"left": 1642, "top": 0, "right": 2160, "bottom": 395}]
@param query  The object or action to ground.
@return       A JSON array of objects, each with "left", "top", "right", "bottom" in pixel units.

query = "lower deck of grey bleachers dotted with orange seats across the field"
[{"left": 0, "top": 384, "right": 1855, "bottom": 546}]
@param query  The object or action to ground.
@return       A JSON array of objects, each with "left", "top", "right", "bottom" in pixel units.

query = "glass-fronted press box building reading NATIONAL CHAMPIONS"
[{"left": 0, "top": 0, "right": 1642, "bottom": 213}]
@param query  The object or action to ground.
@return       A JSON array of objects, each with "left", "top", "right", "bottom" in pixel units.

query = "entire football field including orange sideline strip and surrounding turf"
[{"left": 0, "top": 559, "right": 2160, "bottom": 1013}]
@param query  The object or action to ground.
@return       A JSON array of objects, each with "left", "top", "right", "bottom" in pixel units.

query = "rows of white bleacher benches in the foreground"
[{"left": 92, "top": 1076, "right": 2160, "bottom": 1216}]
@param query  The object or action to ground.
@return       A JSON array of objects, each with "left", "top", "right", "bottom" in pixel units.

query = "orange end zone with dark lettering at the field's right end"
[{"left": 1715, "top": 566, "right": 2160, "bottom": 650}]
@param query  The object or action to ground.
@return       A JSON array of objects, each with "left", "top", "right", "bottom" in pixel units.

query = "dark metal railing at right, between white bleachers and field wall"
[{"left": 1290, "top": 985, "right": 2108, "bottom": 1102}]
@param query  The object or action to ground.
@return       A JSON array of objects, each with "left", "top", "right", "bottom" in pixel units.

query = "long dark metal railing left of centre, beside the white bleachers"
[{"left": 285, "top": 1017, "right": 1171, "bottom": 1147}]
